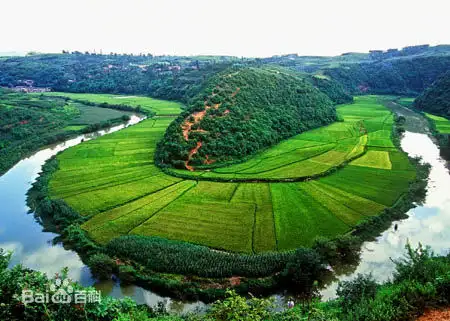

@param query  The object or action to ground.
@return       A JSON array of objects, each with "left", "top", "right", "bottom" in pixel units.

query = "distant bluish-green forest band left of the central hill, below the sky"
[{"left": 0, "top": 52, "right": 242, "bottom": 100}]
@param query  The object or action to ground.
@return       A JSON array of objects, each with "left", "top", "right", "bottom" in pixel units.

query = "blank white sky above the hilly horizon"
[{"left": 0, "top": 0, "right": 450, "bottom": 57}]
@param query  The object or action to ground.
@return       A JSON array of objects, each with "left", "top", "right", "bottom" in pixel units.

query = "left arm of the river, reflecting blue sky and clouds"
[{"left": 0, "top": 115, "right": 203, "bottom": 312}]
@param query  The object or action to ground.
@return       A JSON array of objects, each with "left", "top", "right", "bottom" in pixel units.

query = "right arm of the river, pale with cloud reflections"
[{"left": 321, "top": 132, "right": 450, "bottom": 299}]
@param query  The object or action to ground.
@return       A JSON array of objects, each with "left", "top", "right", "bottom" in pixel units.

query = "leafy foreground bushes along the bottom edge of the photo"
[{"left": 0, "top": 245, "right": 450, "bottom": 321}]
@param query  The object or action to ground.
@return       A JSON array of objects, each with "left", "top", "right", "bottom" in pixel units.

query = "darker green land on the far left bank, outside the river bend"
[{"left": 0, "top": 88, "right": 158, "bottom": 173}]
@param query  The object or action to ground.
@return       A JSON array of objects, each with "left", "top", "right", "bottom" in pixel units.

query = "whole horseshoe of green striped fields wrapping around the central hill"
[{"left": 50, "top": 96, "right": 415, "bottom": 253}]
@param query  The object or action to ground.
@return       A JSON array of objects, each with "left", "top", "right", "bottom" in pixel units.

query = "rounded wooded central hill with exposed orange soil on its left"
[{"left": 156, "top": 67, "right": 336, "bottom": 169}]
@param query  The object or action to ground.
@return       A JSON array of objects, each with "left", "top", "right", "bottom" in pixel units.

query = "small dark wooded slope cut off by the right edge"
[{"left": 414, "top": 71, "right": 450, "bottom": 118}]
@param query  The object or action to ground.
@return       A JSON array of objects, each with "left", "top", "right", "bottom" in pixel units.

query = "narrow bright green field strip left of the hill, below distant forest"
[{"left": 40, "top": 92, "right": 181, "bottom": 116}]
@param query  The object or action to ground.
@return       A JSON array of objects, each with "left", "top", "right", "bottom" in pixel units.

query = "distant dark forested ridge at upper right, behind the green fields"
[{"left": 324, "top": 55, "right": 450, "bottom": 96}]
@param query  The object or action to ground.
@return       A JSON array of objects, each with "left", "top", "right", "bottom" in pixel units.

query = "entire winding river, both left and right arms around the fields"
[{"left": 0, "top": 104, "right": 450, "bottom": 313}]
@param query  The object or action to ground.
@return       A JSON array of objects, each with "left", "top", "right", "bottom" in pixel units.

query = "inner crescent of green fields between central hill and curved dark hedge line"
[{"left": 168, "top": 96, "right": 394, "bottom": 180}]
